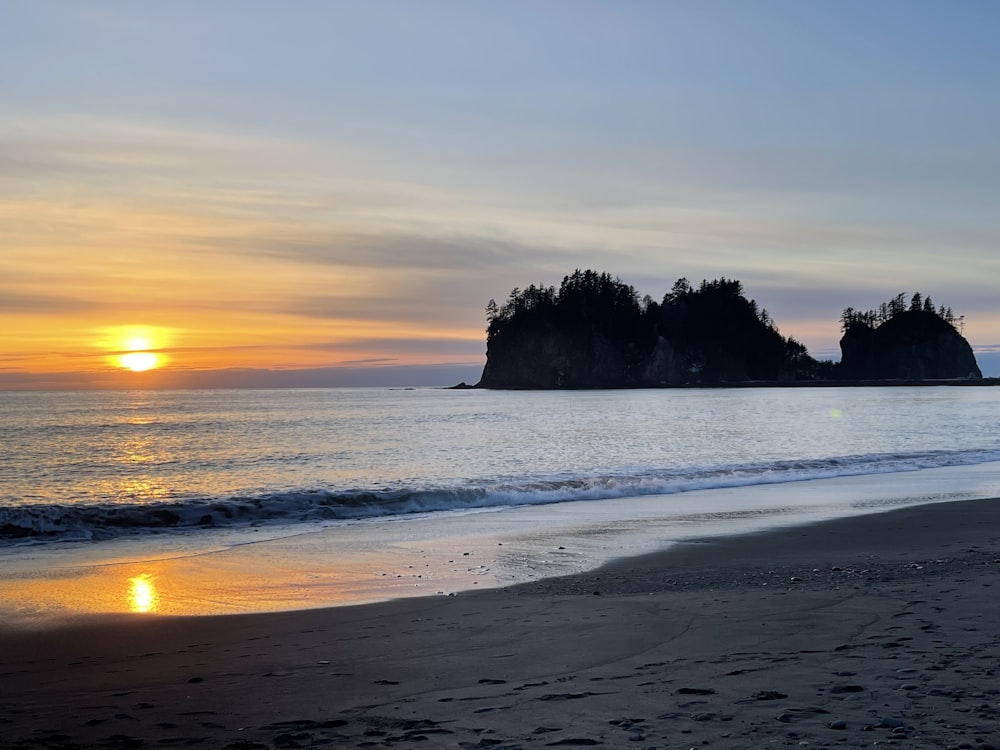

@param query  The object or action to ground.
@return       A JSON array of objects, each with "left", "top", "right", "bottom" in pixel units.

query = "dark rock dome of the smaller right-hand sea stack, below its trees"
[{"left": 840, "top": 310, "right": 982, "bottom": 380}]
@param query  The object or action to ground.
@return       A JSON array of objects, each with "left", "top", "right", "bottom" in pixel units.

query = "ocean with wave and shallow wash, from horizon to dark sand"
[{"left": 0, "top": 387, "right": 1000, "bottom": 614}]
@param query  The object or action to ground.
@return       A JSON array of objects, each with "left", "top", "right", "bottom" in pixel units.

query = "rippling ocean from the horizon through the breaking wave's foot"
[{"left": 0, "top": 387, "right": 1000, "bottom": 545}]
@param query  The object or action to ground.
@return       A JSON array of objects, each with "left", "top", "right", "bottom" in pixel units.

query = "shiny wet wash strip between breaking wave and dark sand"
[{"left": 0, "top": 463, "right": 1000, "bottom": 623}]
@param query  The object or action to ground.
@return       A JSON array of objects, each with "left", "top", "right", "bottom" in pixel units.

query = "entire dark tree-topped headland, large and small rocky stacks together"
[{"left": 474, "top": 269, "right": 990, "bottom": 389}]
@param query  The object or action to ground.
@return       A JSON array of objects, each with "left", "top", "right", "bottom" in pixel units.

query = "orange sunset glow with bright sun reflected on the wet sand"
[{"left": 0, "top": 540, "right": 406, "bottom": 627}]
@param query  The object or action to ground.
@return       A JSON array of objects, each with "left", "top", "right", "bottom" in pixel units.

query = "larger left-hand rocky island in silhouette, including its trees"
[{"left": 479, "top": 271, "right": 816, "bottom": 388}]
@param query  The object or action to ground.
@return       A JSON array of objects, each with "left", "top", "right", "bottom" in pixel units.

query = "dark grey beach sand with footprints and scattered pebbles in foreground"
[{"left": 0, "top": 500, "right": 1000, "bottom": 750}]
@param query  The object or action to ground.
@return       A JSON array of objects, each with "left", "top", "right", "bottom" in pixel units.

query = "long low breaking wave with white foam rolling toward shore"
[{"left": 0, "top": 450, "right": 1000, "bottom": 545}]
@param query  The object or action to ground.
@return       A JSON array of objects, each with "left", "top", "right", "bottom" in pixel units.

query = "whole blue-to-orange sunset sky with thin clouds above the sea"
[{"left": 0, "top": 0, "right": 1000, "bottom": 388}]
